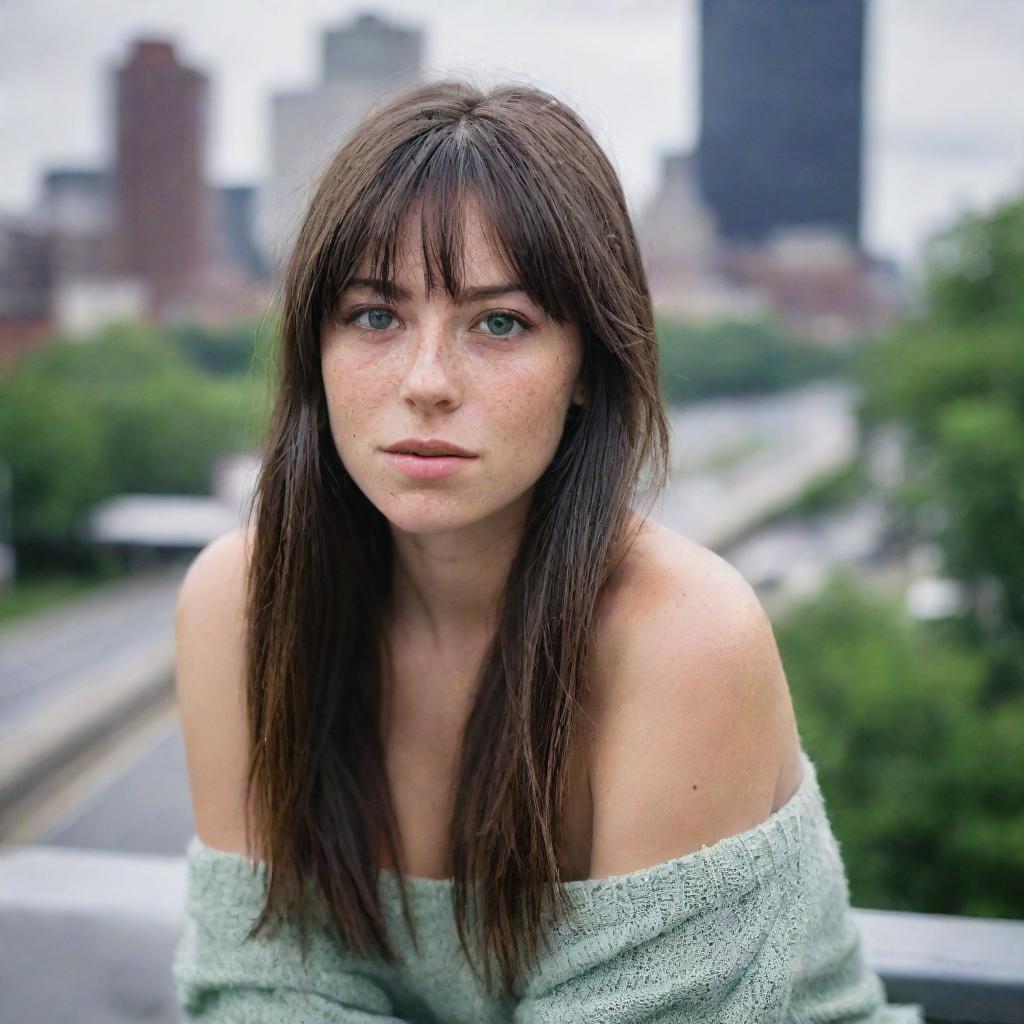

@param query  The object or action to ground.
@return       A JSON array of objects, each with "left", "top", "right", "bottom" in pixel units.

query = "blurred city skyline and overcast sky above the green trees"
[{"left": 0, "top": 0, "right": 1024, "bottom": 355}]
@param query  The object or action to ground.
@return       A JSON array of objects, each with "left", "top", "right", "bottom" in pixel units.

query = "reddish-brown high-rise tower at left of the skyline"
[{"left": 114, "top": 40, "right": 209, "bottom": 316}]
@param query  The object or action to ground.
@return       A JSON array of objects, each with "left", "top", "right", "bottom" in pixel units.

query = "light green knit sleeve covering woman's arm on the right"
[{"left": 514, "top": 794, "right": 924, "bottom": 1024}]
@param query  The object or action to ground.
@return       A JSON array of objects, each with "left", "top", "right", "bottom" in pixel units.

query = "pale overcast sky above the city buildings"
[{"left": 0, "top": 0, "right": 1024, "bottom": 270}]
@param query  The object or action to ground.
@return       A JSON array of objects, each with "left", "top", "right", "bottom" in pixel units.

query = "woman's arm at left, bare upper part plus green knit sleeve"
[{"left": 173, "top": 529, "right": 413, "bottom": 1024}]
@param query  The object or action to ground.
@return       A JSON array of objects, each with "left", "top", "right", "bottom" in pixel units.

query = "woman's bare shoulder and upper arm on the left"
[{"left": 174, "top": 527, "right": 260, "bottom": 855}]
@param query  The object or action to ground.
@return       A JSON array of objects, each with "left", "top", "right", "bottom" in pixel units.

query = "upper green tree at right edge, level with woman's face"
[{"left": 856, "top": 191, "right": 1024, "bottom": 667}]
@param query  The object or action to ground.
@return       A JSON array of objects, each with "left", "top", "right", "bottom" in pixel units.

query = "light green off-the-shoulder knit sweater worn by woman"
[{"left": 173, "top": 753, "right": 923, "bottom": 1024}]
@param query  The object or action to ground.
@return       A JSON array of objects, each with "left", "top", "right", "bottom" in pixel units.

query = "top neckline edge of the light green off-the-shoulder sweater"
[{"left": 186, "top": 749, "right": 818, "bottom": 898}]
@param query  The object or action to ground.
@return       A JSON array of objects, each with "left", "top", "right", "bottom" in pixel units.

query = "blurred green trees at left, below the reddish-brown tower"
[{"left": 0, "top": 323, "right": 267, "bottom": 549}]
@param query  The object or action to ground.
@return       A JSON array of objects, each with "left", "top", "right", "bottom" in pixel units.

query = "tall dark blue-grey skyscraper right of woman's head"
[{"left": 697, "top": 0, "right": 866, "bottom": 245}]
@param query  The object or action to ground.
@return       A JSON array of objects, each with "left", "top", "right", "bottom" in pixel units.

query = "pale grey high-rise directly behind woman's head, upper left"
[{"left": 255, "top": 13, "right": 424, "bottom": 269}]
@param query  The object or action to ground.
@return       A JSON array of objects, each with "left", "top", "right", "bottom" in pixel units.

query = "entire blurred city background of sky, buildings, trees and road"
[{"left": 0, "top": 0, "right": 1024, "bottom": 1021}]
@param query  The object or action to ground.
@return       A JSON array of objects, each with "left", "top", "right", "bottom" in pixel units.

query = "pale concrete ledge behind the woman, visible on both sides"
[{"left": 0, "top": 846, "right": 1024, "bottom": 1024}]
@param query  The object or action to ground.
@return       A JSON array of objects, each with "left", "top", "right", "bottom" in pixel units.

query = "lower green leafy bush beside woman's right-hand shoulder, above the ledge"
[{"left": 774, "top": 571, "right": 1024, "bottom": 918}]
